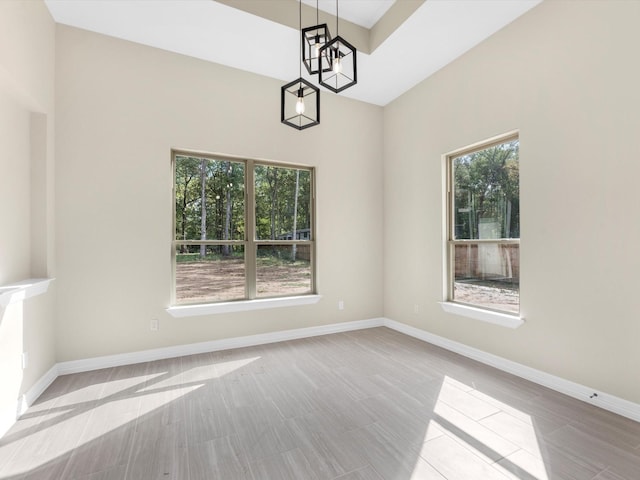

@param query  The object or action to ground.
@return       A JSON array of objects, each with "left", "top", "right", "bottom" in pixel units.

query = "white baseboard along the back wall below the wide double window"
[{"left": 58, "top": 318, "right": 385, "bottom": 375}]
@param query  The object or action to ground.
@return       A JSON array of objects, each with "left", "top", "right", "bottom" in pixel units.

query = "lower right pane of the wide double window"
[{"left": 256, "top": 244, "right": 311, "bottom": 297}]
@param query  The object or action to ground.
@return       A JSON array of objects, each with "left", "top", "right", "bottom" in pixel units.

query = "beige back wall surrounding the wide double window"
[{"left": 56, "top": 26, "right": 383, "bottom": 361}]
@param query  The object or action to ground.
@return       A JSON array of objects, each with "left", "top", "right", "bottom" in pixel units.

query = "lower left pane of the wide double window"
[{"left": 176, "top": 245, "right": 245, "bottom": 304}]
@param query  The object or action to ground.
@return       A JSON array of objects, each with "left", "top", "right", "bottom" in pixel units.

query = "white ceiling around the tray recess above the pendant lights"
[{"left": 45, "top": 0, "right": 542, "bottom": 105}]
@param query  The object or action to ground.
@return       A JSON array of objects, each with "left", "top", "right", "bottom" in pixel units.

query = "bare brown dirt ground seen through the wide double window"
[{"left": 176, "top": 257, "right": 311, "bottom": 303}]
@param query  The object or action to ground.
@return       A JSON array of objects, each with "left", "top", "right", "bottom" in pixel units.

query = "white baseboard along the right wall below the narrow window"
[{"left": 384, "top": 318, "right": 640, "bottom": 422}]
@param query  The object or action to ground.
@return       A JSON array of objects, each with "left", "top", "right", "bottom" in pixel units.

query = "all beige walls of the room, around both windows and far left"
[{"left": 6, "top": 1, "right": 640, "bottom": 411}]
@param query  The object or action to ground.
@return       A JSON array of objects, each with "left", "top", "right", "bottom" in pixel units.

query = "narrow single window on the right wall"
[{"left": 447, "top": 135, "right": 520, "bottom": 314}]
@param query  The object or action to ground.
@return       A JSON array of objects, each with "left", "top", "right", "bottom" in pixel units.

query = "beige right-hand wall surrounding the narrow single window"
[{"left": 384, "top": 1, "right": 640, "bottom": 402}]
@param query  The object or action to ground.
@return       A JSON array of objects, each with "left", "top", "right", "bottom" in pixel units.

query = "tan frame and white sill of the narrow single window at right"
[{"left": 441, "top": 130, "right": 524, "bottom": 318}]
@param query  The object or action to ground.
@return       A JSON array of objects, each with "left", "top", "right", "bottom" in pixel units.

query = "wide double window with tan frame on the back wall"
[{"left": 173, "top": 152, "right": 315, "bottom": 305}]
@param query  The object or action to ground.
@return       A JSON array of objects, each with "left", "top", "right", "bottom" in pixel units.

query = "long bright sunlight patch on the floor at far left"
[{"left": 3, "top": 357, "right": 260, "bottom": 475}]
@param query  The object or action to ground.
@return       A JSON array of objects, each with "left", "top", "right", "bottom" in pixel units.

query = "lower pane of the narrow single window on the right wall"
[{"left": 453, "top": 243, "right": 520, "bottom": 313}]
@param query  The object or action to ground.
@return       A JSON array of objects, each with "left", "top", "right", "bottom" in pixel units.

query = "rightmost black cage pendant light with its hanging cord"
[{"left": 318, "top": 0, "right": 358, "bottom": 93}]
